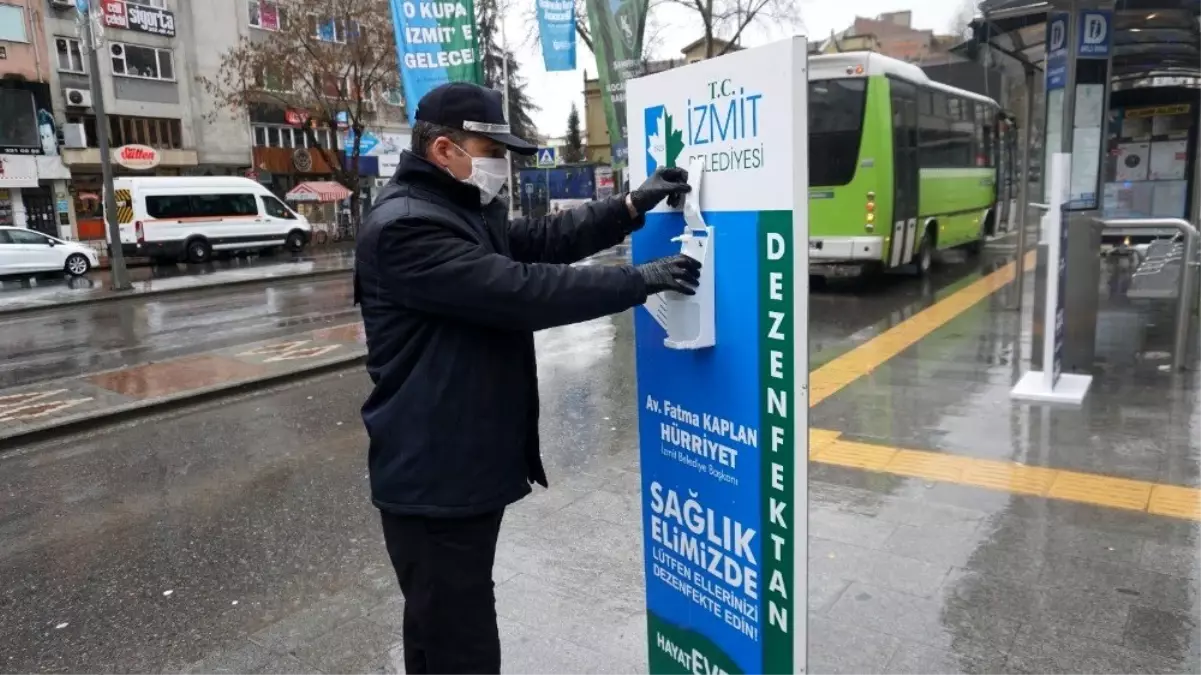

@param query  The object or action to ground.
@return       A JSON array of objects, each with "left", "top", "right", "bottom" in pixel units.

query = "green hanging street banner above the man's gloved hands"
[{"left": 586, "top": 0, "right": 649, "bottom": 168}]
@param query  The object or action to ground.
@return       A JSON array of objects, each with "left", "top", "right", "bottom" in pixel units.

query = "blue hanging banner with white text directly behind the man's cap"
[{"left": 389, "top": 0, "right": 484, "bottom": 126}]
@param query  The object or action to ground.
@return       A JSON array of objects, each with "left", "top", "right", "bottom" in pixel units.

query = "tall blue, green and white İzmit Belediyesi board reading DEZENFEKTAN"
[{"left": 628, "top": 37, "right": 809, "bottom": 675}]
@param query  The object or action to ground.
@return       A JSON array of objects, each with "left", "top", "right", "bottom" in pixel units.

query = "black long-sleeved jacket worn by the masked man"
[{"left": 354, "top": 153, "right": 646, "bottom": 516}]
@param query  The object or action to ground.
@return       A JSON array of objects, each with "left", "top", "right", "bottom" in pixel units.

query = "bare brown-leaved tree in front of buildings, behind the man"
[{"left": 197, "top": 0, "right": 400, "bottom": 221}]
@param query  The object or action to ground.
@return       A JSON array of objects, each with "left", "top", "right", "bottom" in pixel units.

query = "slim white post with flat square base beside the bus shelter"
[{"left": 1010, "top": 153, "right": 1093, "bottom": 406}]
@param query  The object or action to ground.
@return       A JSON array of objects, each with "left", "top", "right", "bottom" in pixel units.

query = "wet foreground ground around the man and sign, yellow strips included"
[{"left": 7, "top": 239, "right": 1201, "bottom": 675}]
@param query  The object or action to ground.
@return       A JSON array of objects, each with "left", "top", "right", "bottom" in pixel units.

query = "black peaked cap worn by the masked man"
[{"left": 416, "top": 82, "right": 538, "bottom": 155}]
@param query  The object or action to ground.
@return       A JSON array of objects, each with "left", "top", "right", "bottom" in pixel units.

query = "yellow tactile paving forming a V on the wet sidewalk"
[{"left": 809, "top": 252, "right": 1201, "bottom": 521}]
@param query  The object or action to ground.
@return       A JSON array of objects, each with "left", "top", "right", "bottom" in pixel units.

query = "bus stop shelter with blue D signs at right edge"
[{"left": 956, "top": 0, "right": 1201, "bottom": 372}]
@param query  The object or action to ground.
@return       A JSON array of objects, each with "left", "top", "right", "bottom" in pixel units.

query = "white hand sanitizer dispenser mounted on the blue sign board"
[{"left": 662, "top": 159, "right": 717, "bottom": 350}]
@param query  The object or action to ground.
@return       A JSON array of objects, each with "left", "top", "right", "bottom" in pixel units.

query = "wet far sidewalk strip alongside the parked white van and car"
[{"left": 0, "top": 247, "right": 354, "bottom": 316}]
